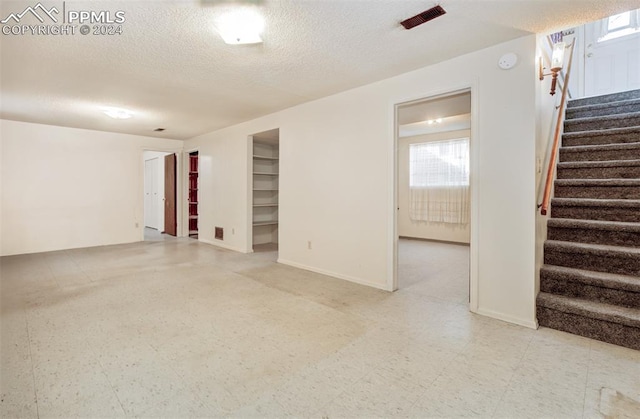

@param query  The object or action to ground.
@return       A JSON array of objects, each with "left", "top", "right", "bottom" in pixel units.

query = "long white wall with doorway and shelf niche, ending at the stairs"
[{"left": 187, "top": 35, "right": 539, "bottom": 327}]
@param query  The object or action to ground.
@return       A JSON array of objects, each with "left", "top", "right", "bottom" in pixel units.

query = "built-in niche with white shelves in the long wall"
[{"left": 251, "top": 129, "right": 280, "bottom": 250}]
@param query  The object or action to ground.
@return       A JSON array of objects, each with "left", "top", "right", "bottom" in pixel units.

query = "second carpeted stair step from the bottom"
[{"left": 540, "top": 265, "right": 640, "bottom": 309}]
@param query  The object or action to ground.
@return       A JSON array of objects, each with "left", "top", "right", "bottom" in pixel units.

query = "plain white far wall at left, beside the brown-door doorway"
[{"left": 0, "top": 120, "right": 183, "bottom": 255}]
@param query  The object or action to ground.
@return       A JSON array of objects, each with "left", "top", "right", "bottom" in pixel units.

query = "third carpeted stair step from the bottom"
[{"left": 544, "top": 240, "right": 640, "bottom": 276}]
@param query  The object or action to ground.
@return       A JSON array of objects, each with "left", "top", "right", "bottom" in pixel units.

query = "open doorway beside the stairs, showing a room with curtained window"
[{"left": 395, "top": 90, "right": 472, "bottom": 304}]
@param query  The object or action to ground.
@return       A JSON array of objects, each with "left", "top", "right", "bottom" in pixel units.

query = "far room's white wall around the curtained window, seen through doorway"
[{"left": 398, "top": 130, "right": 471, "bottom": 243}]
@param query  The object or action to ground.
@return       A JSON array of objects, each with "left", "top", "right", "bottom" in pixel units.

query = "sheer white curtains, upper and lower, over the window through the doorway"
[{"left": 409, "top": 138, "right": 470, "bottom": 224}]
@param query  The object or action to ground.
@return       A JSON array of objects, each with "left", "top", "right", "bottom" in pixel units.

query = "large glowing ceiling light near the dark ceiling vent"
[{"left": 215, "top": 7, "right": 264, "bottom": 45}]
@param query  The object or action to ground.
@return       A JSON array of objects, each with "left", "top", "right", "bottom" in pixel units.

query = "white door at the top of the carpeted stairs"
[{"left": 584, "top": 11, "right": 640, "bottom": 96}]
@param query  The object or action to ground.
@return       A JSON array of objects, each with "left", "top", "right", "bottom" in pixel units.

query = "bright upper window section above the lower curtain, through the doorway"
[{"left": 409, "top": 138, "right": 469, "bottom": 188}]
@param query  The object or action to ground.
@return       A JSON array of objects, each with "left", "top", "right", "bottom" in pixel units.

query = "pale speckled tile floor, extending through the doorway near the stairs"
[{"left": 0, "top": 239, "right": 640, "bottom": 418}]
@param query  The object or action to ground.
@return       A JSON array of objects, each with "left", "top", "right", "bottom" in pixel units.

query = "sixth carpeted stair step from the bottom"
[{"left": 555, "top": 179, "right": 640, "bottom": 199}]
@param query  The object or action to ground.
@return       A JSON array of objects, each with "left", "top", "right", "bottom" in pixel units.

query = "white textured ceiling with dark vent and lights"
[{"left": 0, "top": 0, "right": 638, "bottom": 139}]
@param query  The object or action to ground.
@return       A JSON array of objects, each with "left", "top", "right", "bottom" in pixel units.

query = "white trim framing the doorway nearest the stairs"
[{"left": 387, "top": 81, "right": 481, "bottom": 312}]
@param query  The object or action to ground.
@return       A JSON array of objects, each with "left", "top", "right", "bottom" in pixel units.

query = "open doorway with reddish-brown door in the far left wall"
[{"left": 143, "top": 150, "right": 177, "bottom": 241}]
